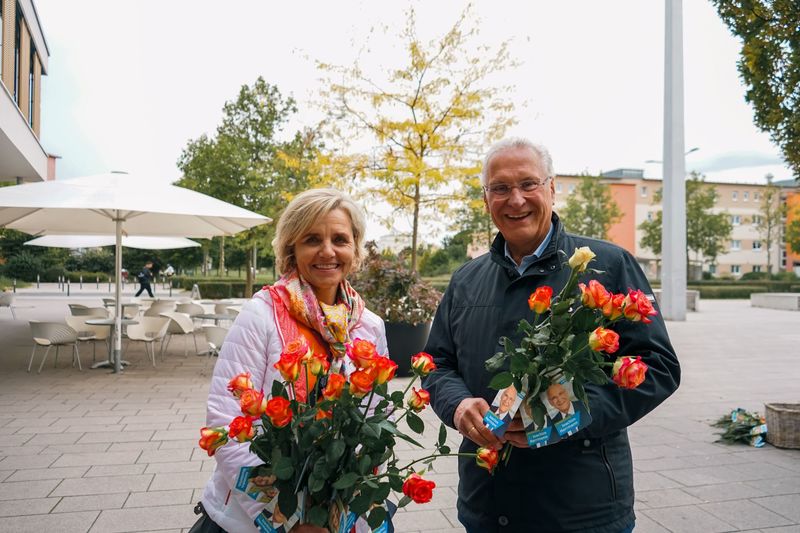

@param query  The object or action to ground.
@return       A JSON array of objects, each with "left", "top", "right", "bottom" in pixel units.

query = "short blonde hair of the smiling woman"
[{"left": 272, "top": 189, "right": 367, "bottom": 274}]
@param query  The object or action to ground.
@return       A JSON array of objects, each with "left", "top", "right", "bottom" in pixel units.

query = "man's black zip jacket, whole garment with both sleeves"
[{"left": 423, "top": 214, "right": 680, "bottom": 533}]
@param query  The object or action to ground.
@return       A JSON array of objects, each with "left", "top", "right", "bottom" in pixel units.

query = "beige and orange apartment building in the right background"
[{"left": 555, "top": 169, "right": 800, "bottom": 278}]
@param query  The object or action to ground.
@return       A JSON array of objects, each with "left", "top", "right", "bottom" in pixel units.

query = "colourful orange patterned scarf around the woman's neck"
[{"left": 271, "top": 269, "right": 364, "bottom": 358}]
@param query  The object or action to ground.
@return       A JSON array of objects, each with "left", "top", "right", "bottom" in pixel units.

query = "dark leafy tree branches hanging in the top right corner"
[{"left": 712, "top": 0, "right": 800, "bottom": 176}]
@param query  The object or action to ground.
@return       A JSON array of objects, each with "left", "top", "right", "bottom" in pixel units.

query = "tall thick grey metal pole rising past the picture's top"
[{"left": 661, "top": 0, "right": 687, "bottom": 320}]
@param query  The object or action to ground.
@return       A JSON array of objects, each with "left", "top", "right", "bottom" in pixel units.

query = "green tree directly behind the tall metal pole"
[{"left": 639, "top": 172, "right": 733, "bottom": 271}]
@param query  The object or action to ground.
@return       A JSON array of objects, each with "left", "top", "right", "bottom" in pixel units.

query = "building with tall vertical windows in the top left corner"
[{"left": 0, "top": 0, "right": 50, "bottom": 183}]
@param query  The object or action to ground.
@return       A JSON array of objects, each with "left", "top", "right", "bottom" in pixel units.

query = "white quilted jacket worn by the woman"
[{"left": 202, "top": 291, "right": 388, "bottom": 533}]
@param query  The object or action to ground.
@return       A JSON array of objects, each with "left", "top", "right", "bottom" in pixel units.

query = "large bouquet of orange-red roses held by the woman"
[{"left": 200, "top": 337, "right": 488, "bottom": 532}]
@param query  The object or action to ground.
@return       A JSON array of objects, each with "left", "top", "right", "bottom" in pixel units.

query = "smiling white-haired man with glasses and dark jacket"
[{"left": 424, "top": 139, "right": 680, "bottom": 533}]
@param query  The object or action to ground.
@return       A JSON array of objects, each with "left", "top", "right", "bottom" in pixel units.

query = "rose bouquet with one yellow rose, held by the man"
[{"left": 485, "top": 247, "right": 656, "bottom": 454}]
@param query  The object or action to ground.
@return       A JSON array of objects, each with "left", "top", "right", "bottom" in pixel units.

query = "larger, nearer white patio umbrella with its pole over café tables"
[{"left": 0, "top": 172, "right": 271, "bottom": 372}]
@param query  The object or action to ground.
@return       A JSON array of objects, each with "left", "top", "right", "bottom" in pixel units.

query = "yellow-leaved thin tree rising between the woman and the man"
[{"left": 318, "top": 8, "right": 515, "bottom": 271}]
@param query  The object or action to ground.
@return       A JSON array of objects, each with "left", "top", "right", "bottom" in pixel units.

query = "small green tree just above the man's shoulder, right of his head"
[{"left": 559, "top": 175, "right": 622, "bottom": 240}]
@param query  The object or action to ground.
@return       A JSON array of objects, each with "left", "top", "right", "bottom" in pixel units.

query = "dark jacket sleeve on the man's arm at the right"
[{"left": 581, "top": 252, "right": 680, "bottom": 437}]
